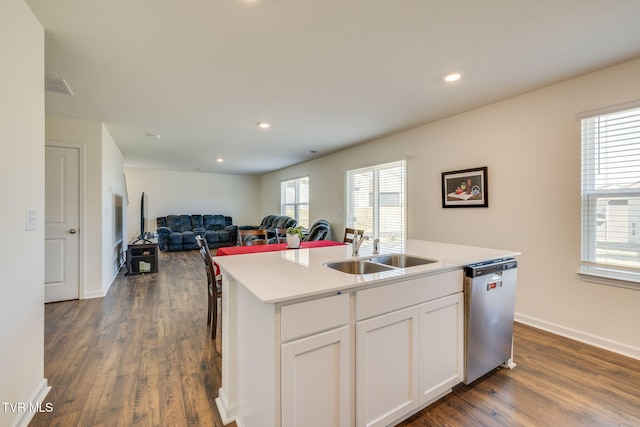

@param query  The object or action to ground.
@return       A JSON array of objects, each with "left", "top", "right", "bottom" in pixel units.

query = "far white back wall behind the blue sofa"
[{"left": 124, "top": 167, "right": 260, "bottom": 239}]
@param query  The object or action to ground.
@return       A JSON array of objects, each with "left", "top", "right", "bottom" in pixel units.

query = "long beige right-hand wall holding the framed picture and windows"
[{"left": 261, "top": 56, "right": 640, "bottom": 358}]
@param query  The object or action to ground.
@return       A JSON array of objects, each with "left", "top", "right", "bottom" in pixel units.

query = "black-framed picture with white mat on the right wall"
[{"left": 442, "top": 166, "right": 489, "bottom": 208}]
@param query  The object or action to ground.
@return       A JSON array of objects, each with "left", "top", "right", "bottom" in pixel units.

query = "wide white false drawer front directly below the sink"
[{"left": 356, "top": 270, "right": 463, "bottom": 320}]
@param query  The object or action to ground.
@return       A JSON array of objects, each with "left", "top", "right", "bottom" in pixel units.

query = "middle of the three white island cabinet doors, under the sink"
[{"left": 356, "top": 306, "right": 419, "bottom": 426}]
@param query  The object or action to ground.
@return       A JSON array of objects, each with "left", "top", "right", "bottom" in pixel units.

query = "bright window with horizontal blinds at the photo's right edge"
[{"left": 580, "top": 108, "right": 640, "bottom": 287}]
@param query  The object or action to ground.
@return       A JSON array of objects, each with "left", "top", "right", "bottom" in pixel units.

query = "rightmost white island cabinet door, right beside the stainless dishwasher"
[{"left": 419, "top": 292, "right": 464, "bottom": 405}]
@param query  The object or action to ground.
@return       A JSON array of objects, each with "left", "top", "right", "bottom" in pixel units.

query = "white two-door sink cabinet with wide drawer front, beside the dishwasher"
[{"left": 356, "top": 271, "right": 464, "bottom": 427}]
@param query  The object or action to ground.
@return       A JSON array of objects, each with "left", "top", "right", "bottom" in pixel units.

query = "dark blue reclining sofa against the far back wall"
[{"left": 156, "top": 215, "right": 238, "bottom": 251}]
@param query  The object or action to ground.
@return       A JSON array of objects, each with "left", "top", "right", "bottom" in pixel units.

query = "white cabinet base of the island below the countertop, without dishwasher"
[{"left": 216, "top": 270, "right": 464, "bottom": 427}]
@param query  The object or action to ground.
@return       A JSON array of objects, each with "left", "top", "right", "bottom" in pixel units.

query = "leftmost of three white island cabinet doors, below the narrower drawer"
[{"left": 281, "top": 326, "right": 351, "bottom": 427}]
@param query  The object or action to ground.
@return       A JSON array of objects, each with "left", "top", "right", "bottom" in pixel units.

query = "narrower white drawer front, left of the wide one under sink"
[{"left": 280, "top": 294, "right": 349, "bottom": 341}]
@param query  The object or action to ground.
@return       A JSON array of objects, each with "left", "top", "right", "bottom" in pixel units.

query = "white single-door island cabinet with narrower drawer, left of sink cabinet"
[{"left": 280, "top": 294, "right": 351, "bottom": 427}]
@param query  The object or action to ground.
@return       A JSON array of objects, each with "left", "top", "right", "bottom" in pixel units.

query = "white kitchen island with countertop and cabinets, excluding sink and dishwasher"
[{"left": 215, "top": 240, "right": 519, "bottom": 427}]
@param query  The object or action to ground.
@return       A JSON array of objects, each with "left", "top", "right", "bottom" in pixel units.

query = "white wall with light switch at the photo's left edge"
[{"left": 0, "top": 0, "right": 46, "bottom": 426}]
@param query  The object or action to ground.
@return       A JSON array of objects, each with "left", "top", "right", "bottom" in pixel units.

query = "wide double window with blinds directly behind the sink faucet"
[{"left": 345, "top": 160, "right": 407, "bottom": 249}]
